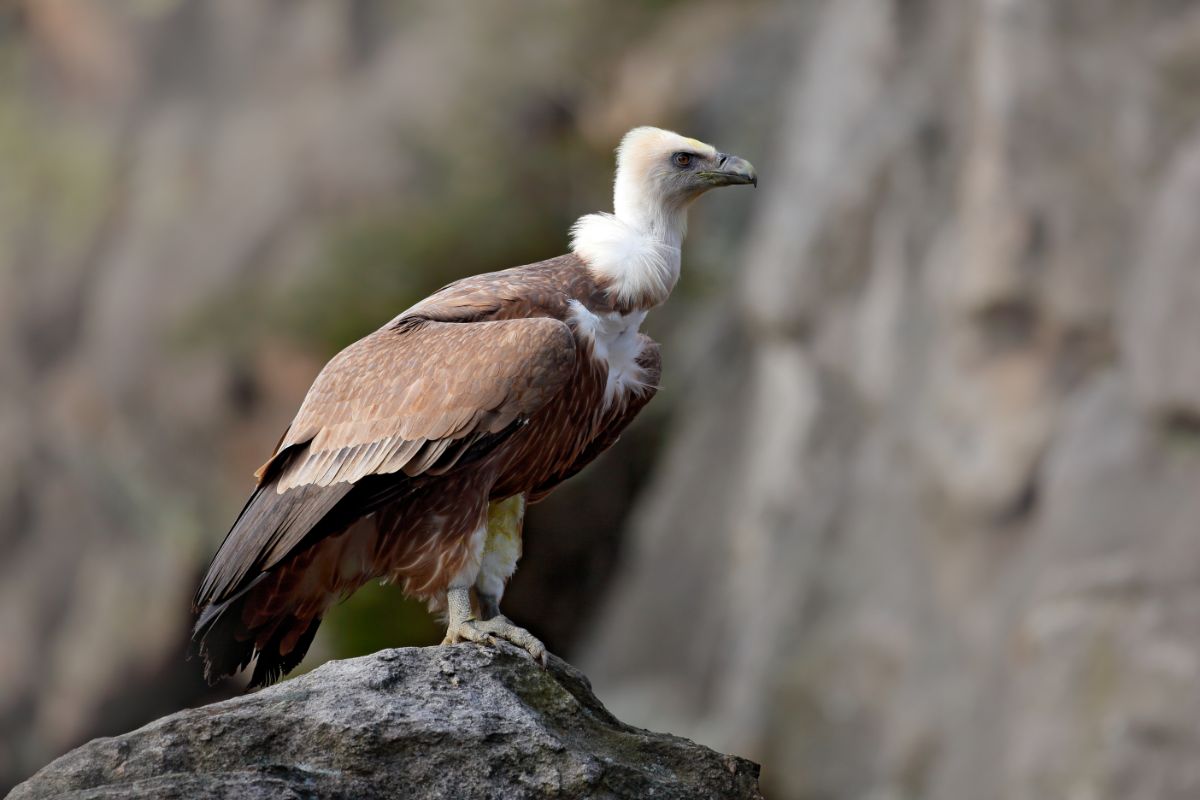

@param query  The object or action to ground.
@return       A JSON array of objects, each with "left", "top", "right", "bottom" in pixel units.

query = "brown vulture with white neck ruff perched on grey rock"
[{"left": 192, "top": 127, "right": 758, "bottom": 690}]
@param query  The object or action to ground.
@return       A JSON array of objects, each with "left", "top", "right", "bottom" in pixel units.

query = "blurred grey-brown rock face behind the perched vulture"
[{"left": 0, "top": 0, "right": 1200, "bottom": 800}]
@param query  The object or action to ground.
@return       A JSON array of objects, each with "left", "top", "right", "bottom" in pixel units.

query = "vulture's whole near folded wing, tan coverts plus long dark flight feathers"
[{"left": 197, "top": 318, "right": 575, "bottom": 606}]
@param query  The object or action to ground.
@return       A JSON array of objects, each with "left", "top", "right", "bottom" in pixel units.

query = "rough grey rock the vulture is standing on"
[{"left": 10, "top": 644, "right": 762, "bottom": 800}]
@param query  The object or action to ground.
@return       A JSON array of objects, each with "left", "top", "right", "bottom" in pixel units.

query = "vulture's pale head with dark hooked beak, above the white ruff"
[{"left": 613, "top": 127, "right": 758, "bottom": 231}]
